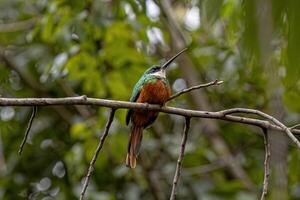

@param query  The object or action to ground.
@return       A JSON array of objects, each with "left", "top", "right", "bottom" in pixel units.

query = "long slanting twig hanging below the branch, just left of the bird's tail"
[{"left": 80, "top": 109, "right": 116, "bottom": 200}]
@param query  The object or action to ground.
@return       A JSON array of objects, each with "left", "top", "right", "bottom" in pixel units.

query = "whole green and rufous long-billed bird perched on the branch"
[{"left": 126, "top": 48, "right": 187, "bottom": 168}]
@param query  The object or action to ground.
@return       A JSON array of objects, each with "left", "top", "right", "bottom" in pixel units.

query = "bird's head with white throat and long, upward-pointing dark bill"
[{"left": 144, "top": 48, "right": 187, "bottom": 78}]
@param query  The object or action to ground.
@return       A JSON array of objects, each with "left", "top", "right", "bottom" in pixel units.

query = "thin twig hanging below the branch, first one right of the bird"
[{"left": 170, "top": 117, "right": 191, "bottom": 200}]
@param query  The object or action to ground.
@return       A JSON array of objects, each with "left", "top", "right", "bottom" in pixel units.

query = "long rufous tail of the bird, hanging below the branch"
[{"left": 126, "top": 125, "right": 143, "bottom": 168}]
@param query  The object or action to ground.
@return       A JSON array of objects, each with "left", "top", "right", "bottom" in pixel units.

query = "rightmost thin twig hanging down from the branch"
[{"left": 260, "top": 128, "right": 271, "bottom": 200}]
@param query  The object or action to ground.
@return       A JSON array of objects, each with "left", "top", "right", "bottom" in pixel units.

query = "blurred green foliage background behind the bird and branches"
[{"left": 0, "top": 0, "right": 300, "bottom": 200}]
